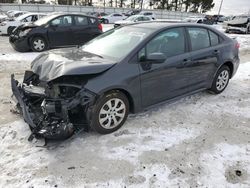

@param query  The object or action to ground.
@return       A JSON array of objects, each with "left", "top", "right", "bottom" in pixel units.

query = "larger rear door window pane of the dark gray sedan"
[{"left": 188, "top": 27, "right": 210, "bottom": 51}]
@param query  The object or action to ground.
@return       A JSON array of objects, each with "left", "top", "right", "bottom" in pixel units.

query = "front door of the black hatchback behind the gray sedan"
[{"left": 48, "top": 16, "right": 73, "bottom": 47}]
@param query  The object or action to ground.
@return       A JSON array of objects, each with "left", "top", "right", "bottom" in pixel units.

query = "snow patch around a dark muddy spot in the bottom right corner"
[{"left": 199, "top": 143, "right": 250, "bottom": 188}]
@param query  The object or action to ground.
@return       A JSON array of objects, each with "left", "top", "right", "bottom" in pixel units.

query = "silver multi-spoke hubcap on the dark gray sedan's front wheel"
[{"left": 99, "top": 98, "right": 126, "bottom": 129}]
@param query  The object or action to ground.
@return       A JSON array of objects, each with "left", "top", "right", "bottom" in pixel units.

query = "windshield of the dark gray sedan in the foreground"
[{"left": 82, "top": 26, "right": 152, "bottom": 60}]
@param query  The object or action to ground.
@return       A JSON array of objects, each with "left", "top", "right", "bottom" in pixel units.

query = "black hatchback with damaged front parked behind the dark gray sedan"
[{"left": 9, "top": 13, "right": 102, "bottom": 52}]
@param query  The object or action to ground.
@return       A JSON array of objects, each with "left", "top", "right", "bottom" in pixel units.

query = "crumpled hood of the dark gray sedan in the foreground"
[{"left": 31, "top": 48, "right": 116, "bottom": 82}]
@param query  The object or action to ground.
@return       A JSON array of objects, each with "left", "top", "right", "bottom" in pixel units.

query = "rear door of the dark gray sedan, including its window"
[{"left": 185, "top": 27, "right": 221, "bottom": 91}]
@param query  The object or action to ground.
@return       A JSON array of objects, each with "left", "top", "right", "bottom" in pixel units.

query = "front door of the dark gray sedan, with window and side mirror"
[{"left": 138, "top": 27, "right": 190, "bottom": 107}]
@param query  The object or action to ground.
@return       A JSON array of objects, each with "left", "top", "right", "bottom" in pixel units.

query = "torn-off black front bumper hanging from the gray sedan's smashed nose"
[{"left": 11, "top": 74, "right": 96, "bottom": 140}]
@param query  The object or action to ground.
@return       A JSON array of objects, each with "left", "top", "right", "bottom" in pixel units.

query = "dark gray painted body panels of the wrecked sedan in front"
[{"left": 32, "top": 23, "right": 239, "bottom": 112}]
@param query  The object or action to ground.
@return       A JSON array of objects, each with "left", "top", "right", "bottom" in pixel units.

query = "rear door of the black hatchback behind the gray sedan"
[{"left": 72, "top": 15, "right": 98, "bottom": 45}]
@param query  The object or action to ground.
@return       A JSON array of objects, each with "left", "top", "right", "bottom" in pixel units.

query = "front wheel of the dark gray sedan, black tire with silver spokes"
[{"left": 88, "top": 91, "right": 129, "bottom": 134}]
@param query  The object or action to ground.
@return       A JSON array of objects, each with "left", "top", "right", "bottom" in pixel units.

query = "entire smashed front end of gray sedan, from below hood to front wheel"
[{"left": 11, "top": 71, "right": 96, "bottom": 140}]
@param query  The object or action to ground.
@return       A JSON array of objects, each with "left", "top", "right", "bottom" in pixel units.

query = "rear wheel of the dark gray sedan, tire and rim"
[{"left": 209, "top": 65, "right": 231, "bottom": 94}]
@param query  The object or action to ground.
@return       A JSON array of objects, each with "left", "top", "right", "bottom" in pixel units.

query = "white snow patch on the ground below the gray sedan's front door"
[{"left": 102, "top": 126, "right": 201, "bottom": 164}]
